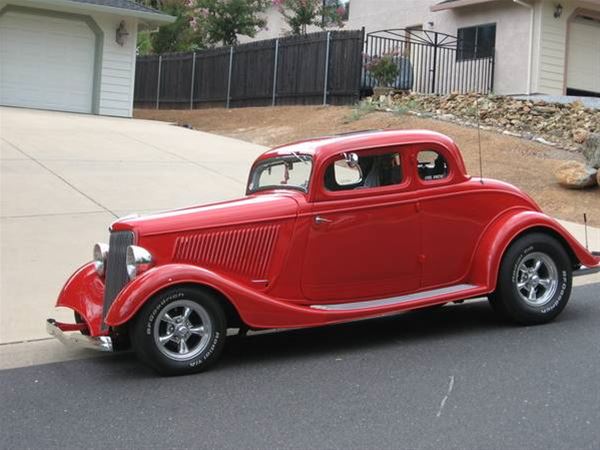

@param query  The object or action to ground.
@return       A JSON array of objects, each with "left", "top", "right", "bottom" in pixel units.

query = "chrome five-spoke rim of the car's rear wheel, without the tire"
[{"left": 517, "top": 252, "right": 558, "bottom": 306}]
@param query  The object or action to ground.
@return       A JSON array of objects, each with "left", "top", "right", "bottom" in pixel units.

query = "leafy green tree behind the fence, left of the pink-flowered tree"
[{"left": 196, "top": 0, "right": 271, "bottom": 45}]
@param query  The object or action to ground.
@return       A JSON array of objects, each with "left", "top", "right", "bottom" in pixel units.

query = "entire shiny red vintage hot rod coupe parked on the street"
[{"left": 47, "top": 131, "right": 600, "bottom": 374}]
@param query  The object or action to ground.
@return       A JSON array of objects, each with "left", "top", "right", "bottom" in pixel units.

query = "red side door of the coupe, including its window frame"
[{"left": 302, "top": 147, "right": 421, "bottom": 302}]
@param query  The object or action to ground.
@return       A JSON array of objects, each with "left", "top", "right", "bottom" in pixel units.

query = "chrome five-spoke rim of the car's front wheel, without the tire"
[{"left": 153, "top": 300, "right": 212, "bottom": 361}]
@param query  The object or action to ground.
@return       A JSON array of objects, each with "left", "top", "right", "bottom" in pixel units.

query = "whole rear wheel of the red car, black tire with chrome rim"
[{"left": 489, "top": 233, "right": 573, "bottom": 325}]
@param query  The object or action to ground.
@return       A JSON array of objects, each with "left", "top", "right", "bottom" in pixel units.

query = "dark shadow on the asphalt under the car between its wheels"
[{"left": 213, "top": 301, "right": 502, "bottom": 370}]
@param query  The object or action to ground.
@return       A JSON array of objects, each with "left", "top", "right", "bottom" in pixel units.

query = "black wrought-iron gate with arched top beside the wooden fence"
[{"left": 362, "top": 28, "right": 494, "bottom": 94}]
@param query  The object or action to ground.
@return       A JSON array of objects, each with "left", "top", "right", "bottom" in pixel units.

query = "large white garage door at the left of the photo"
[{"left": 0, "top": 11, "right": 95, "bottom": 113}]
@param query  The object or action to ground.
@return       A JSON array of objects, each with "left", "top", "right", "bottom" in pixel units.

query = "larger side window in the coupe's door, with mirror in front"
[{"left": 324, "top": 152, "right": 403, "bottom": 191}]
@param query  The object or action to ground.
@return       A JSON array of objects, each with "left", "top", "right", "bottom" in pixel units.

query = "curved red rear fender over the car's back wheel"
[{"left": 469, "top": 209, "right": 600, "bottom": 292}]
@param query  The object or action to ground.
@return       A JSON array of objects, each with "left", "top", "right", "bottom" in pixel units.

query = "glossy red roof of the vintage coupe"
[{"left": 258, "top": 130, "right": 462, "bottom": 160}]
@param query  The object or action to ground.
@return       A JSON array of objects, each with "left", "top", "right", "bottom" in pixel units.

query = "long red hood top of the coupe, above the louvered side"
[{"left": 111, "top": 193, "right": 298, "bottom": 236}]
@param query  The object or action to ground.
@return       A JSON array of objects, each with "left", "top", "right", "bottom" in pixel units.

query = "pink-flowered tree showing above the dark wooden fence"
[{"left": 273, "top": 0, "right": 346, "bottom": 35}]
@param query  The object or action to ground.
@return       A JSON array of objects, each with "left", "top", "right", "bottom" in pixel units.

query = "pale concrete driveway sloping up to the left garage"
[{"left": 0, "top": 108, "right": 264, "bottom": 344}]
